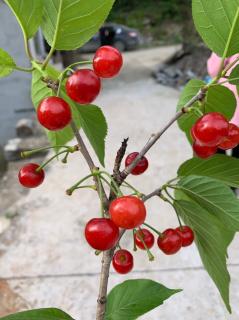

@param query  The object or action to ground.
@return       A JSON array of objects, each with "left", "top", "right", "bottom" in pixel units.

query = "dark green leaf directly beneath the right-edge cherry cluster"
[{"left": 178, "top": 154, "right": 239, "bottom": 188}]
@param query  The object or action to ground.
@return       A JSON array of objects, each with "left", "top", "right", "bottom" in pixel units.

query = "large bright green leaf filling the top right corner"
[{"left": 192, "top": 0, "right": 239, "bottom": 57}]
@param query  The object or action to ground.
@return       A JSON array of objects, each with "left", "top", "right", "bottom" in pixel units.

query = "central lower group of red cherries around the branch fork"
[{"left": 85, "top": 152, "right": 194, "bottom": 274}]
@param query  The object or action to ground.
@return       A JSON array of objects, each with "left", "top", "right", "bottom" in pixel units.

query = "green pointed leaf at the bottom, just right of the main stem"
[{"left": 104, "top": 279, "right": 181, "bottom": 320}]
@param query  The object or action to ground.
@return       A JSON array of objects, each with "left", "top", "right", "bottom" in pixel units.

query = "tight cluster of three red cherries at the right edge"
[{"left": 191, "top": 112, "right": 239, "bottom": 159}]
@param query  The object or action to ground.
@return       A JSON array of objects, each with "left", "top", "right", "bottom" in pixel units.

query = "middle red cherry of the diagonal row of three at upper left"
[{"left": 66, "top": 69, "right": 101, "bottom": 104}]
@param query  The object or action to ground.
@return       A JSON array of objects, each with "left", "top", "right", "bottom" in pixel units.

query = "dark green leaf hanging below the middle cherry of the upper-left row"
[{"left": 77, "top": 105, "right": 108, "bottom": 166}]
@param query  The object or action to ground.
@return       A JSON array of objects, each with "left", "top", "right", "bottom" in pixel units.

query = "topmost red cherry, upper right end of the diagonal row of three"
[{"left": 93, "top": 46, "right": 123, "bottom": 78}]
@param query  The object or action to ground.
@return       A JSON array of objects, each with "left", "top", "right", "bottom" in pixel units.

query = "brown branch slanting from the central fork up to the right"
[{"left": 121, "top": 88, "right": 207, "bottom": 182}]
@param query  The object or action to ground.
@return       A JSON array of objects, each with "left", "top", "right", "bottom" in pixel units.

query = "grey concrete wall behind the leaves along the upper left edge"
[{"left": 0, "top": 1, "right": 32, "bottom": 145}]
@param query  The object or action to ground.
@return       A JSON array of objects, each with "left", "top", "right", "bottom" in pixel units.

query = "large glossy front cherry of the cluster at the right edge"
[{"left": 191, "top": 112, "right": 229, "bottom": 147}]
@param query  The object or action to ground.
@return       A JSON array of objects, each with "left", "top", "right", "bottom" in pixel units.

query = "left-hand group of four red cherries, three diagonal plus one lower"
[{"left": 18, "top": 46, "right": 123, "bottom": 188}]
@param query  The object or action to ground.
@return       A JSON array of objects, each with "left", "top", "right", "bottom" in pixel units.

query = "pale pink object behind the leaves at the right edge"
[{"left": 207, "top": 53, "right": 239, "bottom": 126}]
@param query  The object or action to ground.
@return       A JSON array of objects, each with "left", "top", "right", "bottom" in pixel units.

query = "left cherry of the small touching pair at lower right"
[{"left": 158, "top": 229, "right": 182, "bottom": 255}]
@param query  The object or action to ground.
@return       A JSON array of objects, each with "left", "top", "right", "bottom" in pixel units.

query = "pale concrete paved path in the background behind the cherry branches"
[{"left": 0, "top": 48, "right": 239, "bottom": 320}]
